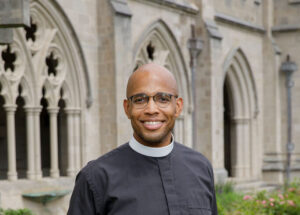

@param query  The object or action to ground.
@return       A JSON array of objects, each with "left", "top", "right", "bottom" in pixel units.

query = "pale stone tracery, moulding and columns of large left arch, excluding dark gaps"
[{"left": 0, "top": 0, "right": 92, "bottom": 180}]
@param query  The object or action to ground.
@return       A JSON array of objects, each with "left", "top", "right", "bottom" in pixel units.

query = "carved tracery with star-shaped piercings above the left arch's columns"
[{"left": 0, "top": 3, "right": 72, "bottom": 107}]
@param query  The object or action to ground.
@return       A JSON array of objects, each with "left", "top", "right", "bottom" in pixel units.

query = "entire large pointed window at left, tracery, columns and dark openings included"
[{"left": 0, "top": 0, "right": 91, "bottom": 180}]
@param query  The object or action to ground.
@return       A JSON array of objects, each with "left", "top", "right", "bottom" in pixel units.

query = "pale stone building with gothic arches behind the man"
[{"left": 0, "top": 0, "right": 300, "bottom": 215}]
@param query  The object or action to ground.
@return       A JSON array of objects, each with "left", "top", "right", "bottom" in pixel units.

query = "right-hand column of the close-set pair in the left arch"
[{"left": 33, "top": 107, "right": 42, "bottom": 179}]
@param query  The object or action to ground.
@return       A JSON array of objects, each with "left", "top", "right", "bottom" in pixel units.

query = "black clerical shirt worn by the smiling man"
[{"left": 68, "top": 142, "right": 217, "bottom": 215}]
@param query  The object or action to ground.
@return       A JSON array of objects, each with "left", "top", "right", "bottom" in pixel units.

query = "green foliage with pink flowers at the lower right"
[{"left": 216, "top": 180, "right": 300, "bottom": 215}]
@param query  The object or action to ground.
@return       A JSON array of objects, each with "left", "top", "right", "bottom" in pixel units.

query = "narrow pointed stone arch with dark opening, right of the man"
[{"left": 223, "top": 48, "right": 258, "bottom": 178}]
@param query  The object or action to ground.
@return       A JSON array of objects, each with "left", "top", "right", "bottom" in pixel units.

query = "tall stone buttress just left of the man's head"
[{"left": 110, "top": 0, "right": 133, "bottom": 148}]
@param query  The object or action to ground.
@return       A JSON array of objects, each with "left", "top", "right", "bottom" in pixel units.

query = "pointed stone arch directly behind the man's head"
[{"left": 132, "top": 20, "right": 193, "bottom": 146}]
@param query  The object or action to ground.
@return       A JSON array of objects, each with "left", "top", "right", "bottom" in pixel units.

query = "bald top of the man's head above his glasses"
[{"left": 126, "top": 63, "right": 178, "bottom": 98}]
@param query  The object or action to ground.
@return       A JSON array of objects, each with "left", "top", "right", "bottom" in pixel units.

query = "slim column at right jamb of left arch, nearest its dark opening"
[{"left": 65, "top": 108, "right": 75, "bottom": 176}]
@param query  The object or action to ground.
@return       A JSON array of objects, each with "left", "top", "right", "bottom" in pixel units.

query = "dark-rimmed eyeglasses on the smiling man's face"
[{"left": 128, "top": 93, "right": 178, "bottom": 109}]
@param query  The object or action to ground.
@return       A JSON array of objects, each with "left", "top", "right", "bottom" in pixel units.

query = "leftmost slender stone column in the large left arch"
[{"left": 4, "top": 105, "right": 17, "bottom": 181}]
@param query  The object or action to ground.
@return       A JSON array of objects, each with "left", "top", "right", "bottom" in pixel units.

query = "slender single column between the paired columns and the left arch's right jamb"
[{"left": 48, "top": 107, "right": 59, "bottom": 178}]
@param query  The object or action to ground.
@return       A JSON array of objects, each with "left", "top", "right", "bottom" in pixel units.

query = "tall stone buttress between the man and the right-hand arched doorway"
[{"left": 200, "top": 18, "right": 228, "bottom": 183}]
